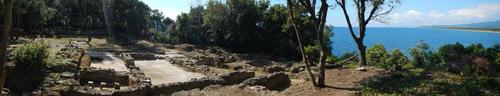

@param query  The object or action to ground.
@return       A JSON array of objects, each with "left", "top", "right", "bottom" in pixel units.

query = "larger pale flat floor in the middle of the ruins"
[{"left": 134, "top": 59, "right": 205, "bottom": 85}]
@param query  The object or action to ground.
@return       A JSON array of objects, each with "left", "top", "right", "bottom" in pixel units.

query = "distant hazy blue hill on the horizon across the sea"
[{"left": 423, "top": 20, "right": 500, "bottom": 29}]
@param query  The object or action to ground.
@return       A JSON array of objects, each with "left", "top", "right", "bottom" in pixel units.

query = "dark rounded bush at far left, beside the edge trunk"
[{"left": 7, "top": 42, "right": 49, "bottom": 93}]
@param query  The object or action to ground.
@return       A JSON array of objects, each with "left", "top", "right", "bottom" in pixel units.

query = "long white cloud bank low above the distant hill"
[{"left": 388, "top": 4, "right": 500, "bottom": 26}]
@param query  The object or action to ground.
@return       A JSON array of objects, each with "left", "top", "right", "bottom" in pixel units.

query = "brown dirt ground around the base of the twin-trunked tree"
[{"left": 173, "top": 69, "right": 384, "bottom": 96}]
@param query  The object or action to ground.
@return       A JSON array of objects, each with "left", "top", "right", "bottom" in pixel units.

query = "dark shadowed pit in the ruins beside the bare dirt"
[{"left": 241, "top": 72, "right": 291, "bottom": 90}]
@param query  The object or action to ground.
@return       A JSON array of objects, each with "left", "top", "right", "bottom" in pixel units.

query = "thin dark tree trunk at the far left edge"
[{"left": 0, "top": 0, "right": 13, "bottom": 95}]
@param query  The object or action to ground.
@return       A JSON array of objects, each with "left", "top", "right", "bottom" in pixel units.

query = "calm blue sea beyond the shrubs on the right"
[{"left": 331, "top": 27, "right": 500, "bottom": 56}]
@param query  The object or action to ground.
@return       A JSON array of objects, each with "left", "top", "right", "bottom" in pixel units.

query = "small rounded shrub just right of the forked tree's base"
[{"left": 366, "top": 44, "right": 390, "bottom": 68}]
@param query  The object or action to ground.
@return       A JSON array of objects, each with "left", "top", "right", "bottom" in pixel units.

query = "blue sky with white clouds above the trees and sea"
[{"left": 142, "top": 0, "right": 500, "bottom": 27}]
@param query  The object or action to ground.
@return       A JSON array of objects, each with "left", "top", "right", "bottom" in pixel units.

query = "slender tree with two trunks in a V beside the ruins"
[{"left": 288, "top": 0, "right": 329, "bottom": 87}]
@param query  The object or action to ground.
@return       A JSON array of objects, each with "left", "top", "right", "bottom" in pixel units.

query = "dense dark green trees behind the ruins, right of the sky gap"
[{"left": 172, "top": 0, "right": 318, "bottom": 59}]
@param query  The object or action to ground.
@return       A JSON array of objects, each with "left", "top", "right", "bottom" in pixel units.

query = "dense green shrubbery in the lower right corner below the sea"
[{"left": 362, "top": 43, "right": 500, "bottom": 95}]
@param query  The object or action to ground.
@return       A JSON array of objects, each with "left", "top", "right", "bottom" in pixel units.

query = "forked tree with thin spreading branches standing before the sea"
[{"left": 335, "top": 0, "right": 400, "bottom": 66}]
